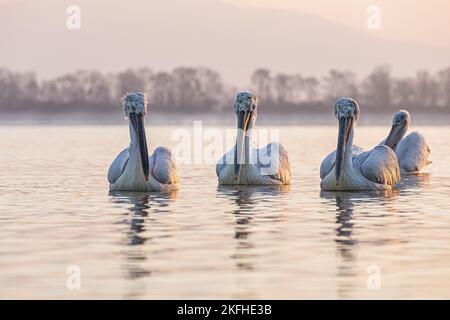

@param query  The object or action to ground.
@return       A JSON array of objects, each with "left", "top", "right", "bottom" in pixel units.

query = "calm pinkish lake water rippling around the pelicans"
[{"left": 0, "top": 123, "right": 450, "bottom": 299}]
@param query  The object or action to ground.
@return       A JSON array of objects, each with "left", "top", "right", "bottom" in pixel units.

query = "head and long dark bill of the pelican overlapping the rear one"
[{"left": 334, "top": 98, "right": 359, "bottom": 185}]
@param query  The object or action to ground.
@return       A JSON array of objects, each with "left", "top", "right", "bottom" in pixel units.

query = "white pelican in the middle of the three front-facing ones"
[{"left": 216, "top": 92, "right": 291, "bottom": 185}]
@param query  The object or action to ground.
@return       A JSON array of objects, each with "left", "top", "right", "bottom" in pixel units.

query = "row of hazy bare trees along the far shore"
[{"left": 0, "top": 66, "right": 450, "bottom": 114}]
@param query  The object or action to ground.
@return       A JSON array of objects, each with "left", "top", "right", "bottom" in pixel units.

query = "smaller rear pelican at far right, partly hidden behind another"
[{"left": 382, "top": 110, "right": 431, "bottom": 172}]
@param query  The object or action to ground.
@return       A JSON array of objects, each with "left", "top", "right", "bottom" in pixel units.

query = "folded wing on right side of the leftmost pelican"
[{"left": 149, "top": 147, "right": 178, "bottom": 184}]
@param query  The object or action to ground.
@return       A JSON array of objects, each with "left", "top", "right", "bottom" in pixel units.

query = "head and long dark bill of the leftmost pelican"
[{"left": 121, "top": 92, "right": 150, "bottom": 181}]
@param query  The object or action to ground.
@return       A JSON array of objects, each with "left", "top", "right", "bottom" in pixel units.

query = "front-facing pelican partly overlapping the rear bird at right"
[{"left": 320, "top": 98, "right": 400, "bottom": 191}]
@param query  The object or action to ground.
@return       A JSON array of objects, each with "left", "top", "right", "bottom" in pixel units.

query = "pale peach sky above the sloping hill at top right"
[{"left": 224, "top": 0, "right": 450, "bottom": 47}]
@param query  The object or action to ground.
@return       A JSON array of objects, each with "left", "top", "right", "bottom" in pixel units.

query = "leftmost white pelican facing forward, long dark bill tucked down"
[{"left": 108, "top": 92, "right": 178, "bottom": 191}]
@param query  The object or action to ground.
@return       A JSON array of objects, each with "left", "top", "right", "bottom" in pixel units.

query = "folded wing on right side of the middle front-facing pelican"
[{"left": 257, "top": 142, "right": 291, "bottom": 184}]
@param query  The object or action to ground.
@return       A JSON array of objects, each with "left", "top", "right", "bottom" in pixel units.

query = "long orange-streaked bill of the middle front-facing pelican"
[{"left": 234, "top": 111, "right": 253, "bottom": 182}]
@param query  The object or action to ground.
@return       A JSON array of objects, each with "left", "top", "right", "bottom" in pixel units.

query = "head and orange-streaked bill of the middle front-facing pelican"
[{"left": 234, "top": 92, "right": 259, "bottom": 180}]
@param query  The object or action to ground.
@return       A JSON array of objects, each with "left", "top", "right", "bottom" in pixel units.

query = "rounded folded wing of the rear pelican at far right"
[{"left": 396, "top": 132, "right": 431, "bottom": 172}]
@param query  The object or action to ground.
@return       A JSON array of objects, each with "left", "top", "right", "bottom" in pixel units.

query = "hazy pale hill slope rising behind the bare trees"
[{"left": 0, "top": 0, "right": 450, "bottom": 85}]
